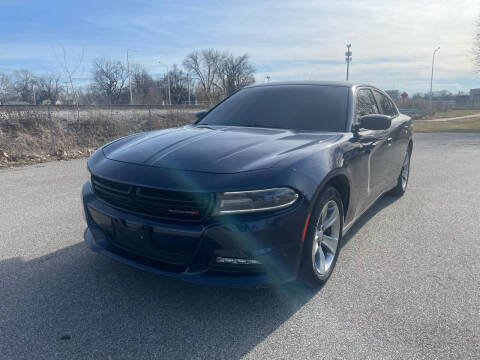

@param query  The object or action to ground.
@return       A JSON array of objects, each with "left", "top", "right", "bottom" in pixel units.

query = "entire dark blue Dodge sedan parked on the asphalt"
[{"left": 82, "top": 82, "right": 413, "bottom": 287}]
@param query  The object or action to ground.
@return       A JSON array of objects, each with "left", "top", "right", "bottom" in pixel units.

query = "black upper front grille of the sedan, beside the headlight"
[{"left": 92, "top": 176, "right": 214, "bottom": 221}]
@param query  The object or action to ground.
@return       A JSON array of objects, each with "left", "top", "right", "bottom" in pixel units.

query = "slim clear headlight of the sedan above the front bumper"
[{"left": 214, "top": 188, "right": 298, "bottom": 215}]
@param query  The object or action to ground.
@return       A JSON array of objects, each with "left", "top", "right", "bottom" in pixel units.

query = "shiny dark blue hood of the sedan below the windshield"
[{"left": 103, "top": 126, "right": 337, "bottom": 173}]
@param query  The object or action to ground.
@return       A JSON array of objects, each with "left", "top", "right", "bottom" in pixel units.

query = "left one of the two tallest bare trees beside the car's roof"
[{"left": 183, "top": 49, "right": 223, "bottom": 105}]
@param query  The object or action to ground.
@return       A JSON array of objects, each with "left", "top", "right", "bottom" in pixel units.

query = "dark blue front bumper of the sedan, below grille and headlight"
[{"left": 82, "top": 182, "right": 308, "bottom": 287}]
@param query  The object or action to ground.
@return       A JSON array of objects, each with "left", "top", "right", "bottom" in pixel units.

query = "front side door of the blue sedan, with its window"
[{"left": 355, "top": 87, "right": 391, "bottom": 207}]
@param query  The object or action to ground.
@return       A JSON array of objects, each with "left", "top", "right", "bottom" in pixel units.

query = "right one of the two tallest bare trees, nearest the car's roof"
[{"left": 218, "top": 53, "right": 255, "bottom": 96}]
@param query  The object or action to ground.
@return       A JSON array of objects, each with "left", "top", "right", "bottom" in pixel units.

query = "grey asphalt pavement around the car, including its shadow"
[{"left": 0, "top": 133, "right": 480, "bottom": 359}]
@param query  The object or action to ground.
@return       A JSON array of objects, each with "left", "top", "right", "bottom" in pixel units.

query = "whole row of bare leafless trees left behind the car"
[{"left": 0, "top": 49, "right": 255, "bottom": 105}]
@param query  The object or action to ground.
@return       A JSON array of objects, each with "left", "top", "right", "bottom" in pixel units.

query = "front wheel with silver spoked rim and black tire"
[{"left": 300, "top": 187, "right": 343, "bottom": 288}]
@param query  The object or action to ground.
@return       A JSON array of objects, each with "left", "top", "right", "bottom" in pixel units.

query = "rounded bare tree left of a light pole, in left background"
[{"left": 93, "top": 59, "right": 128, "bottom": 104}]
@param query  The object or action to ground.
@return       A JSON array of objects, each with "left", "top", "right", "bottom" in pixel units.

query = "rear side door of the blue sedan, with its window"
[{"left": 373, "top": 89, "right": 408, "bottom": 186}]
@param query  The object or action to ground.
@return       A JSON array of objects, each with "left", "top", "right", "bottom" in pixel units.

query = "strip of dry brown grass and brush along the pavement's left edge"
[{"left": 0, "top": 110, "right": 195, "bottom": 167}]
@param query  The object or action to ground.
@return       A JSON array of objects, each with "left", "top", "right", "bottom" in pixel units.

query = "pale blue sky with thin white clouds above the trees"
[{"left": 0, "top": 0, "right": 480, "bottom": 93}]
